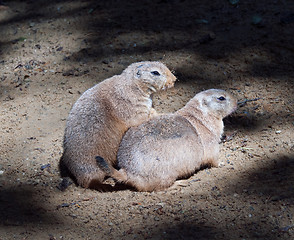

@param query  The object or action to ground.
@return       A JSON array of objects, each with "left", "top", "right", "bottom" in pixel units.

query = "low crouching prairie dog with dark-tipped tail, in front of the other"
[{"left": 96, "top": 89, "right": 237, "bottom": 191}]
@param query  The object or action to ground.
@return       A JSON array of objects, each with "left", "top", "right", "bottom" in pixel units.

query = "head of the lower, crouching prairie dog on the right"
[{"left": 192, "top": 89, "right": 237, "bottom": 118}]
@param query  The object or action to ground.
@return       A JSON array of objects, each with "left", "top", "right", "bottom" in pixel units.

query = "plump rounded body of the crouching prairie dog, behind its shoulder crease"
[{"left": 117, "top": 114, "right": 203, "bottom": 191}]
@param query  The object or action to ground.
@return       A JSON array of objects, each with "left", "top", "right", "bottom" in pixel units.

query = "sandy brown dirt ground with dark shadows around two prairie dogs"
[{"left": 0, "top": 0, "right": 294, "bottom": 240}]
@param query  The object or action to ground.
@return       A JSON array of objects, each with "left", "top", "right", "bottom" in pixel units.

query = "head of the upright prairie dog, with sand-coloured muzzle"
[{"left": 124, "top": 61, "right": 176, "bottom": 92}]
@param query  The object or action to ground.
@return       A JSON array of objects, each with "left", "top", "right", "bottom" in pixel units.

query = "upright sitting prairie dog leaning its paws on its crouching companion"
[{"left": 60, "top": 61, "right": 176, "bottom": 189}]
